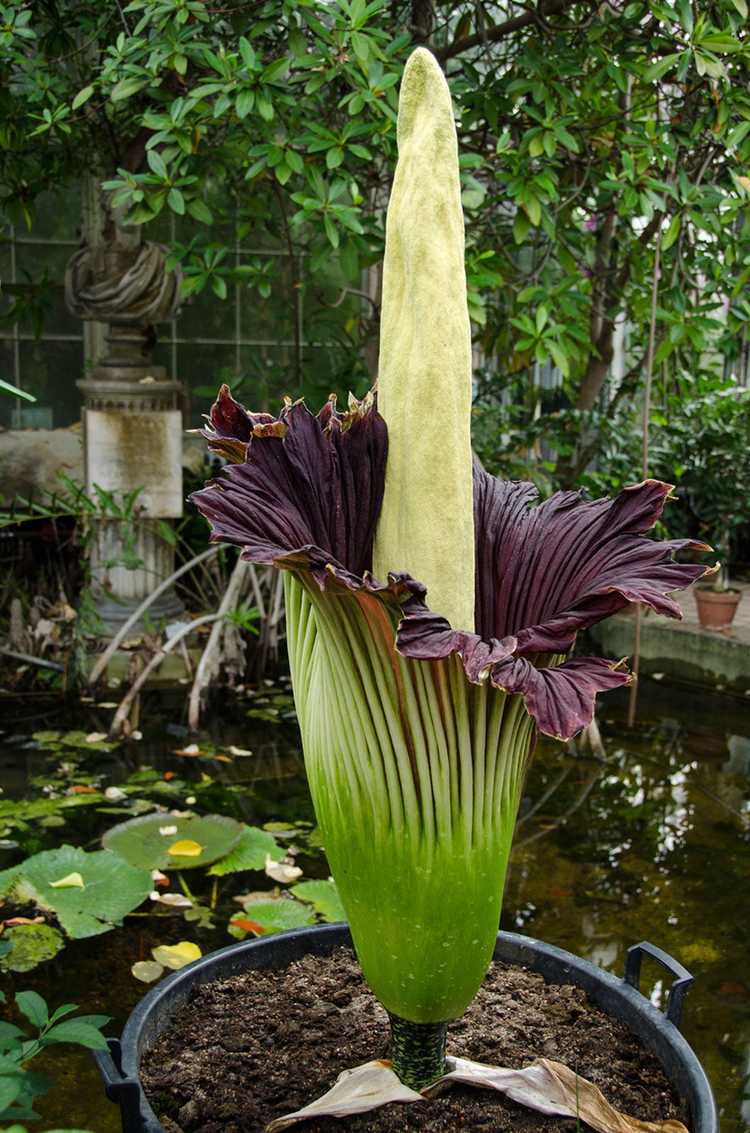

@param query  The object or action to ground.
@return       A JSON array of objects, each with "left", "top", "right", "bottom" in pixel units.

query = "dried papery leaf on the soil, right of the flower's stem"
[{"left": 425, "top": 1058, "right": 688, "bottom": 1133}]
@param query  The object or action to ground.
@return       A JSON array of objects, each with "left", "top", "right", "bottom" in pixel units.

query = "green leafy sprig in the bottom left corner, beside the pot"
[{"left": 0, "top": 991, "right": 109, "bottom": 1133}]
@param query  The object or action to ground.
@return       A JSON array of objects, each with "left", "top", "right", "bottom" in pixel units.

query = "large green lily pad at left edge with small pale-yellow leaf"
[{"left": 0, "top": 845, "right": 152, "bottom": 939}]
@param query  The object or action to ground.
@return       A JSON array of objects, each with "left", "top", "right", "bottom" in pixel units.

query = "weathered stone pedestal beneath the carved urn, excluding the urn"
[{"left": 78, "top": 373, "right": 184, "bottom": 633}]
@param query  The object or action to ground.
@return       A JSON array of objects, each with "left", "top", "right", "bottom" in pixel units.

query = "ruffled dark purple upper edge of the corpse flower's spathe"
[{"left": 191, "top": 387, "right": 710, "bottom": 739}]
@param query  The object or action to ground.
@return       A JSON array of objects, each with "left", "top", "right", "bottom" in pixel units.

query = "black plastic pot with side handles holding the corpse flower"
[{"left": 94, "top": 925, "right": 718, "bottom": 1133}]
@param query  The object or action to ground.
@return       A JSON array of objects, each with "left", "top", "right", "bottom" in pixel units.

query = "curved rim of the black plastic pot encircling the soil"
[{"left": 110, "top": 922, "right": 719, "bottom": 1133}]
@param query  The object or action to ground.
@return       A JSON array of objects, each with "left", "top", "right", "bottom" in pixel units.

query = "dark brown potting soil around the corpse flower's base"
[{"left": 140, "top": 948, "right": 685, "bottom": 1133}]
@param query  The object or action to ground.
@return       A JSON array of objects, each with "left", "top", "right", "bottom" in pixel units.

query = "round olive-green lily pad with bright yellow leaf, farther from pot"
[{"left": 102, "top": 815, "right": 245, "bottom": 869}]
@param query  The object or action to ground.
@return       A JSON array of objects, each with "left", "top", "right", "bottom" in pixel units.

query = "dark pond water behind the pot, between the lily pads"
[{"left": 0, "top": 680, "right": 750, "bottom": 1133}]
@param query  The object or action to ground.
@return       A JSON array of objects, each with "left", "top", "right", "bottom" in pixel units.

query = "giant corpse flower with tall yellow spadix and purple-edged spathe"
[{"left": 194, "top": 49, "right": 704, "bottom": 1128}]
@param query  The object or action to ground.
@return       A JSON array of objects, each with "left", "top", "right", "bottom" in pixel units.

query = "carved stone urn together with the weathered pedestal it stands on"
[{"left": 65, "top": 222, "right": 182, "bottom": 632}]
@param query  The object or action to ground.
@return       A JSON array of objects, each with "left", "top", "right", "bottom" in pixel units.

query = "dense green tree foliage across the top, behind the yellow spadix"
[{"left": 0, "top": 0, "right": 750, "bottom": 464}]
